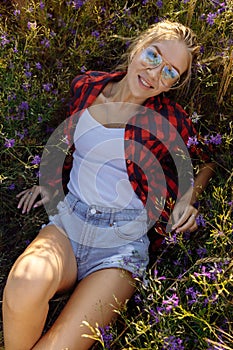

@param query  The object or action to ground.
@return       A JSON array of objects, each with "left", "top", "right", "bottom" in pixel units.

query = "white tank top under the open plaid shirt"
[{"left": 68, "top": 109, "right": 143, "bottom": 209}]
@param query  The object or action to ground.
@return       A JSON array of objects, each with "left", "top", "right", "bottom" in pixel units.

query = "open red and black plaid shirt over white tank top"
[{"left": 44, "top": 71, "right": 210, "bottom": 250}]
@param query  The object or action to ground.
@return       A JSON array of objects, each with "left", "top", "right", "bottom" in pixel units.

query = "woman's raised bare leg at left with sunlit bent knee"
[{"left": 3, "top": 226, "right": 77, "bottom": 350}]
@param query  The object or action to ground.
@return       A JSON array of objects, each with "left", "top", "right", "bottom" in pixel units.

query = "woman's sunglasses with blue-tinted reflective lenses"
[{"left": 141, "top": 46, "right": 180, "bottom": 88}]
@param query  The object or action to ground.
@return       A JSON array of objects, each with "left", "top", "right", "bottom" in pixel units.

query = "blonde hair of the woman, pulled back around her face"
[{"left": 117, "top": 20, "right": 200, "bottom": 87}]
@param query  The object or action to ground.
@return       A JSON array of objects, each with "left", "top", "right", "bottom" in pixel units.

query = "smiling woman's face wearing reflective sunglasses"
[{"left": 127, "top": 40, "right": 190, "bottom": 100}]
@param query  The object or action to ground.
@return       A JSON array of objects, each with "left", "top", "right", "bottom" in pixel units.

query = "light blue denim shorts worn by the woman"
[{"left": 46, "top": 193, "right": 149, "bottom": 280}]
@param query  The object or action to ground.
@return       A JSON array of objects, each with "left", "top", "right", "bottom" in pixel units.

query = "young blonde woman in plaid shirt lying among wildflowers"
[{"left": 3, "top": 21, "right": 213, "bottom": 350}]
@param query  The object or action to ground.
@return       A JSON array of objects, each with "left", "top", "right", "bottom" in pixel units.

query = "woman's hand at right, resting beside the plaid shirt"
[{"left": 169, "top": 202, "right": 198, "bottom": 232}]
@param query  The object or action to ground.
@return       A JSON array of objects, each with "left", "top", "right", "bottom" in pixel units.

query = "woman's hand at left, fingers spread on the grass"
[{"left": 16, "top": 185, "right": 51, "bottom": 214}]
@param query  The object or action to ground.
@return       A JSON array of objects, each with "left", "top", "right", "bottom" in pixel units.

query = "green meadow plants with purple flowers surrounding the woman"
[{"left": 0, "top": 0, "right": 233, "bottom": 350}]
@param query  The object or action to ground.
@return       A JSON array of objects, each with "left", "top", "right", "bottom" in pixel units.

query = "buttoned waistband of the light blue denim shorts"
[{"left": 65, "top": 192, "right": 147, "bottom": 222}]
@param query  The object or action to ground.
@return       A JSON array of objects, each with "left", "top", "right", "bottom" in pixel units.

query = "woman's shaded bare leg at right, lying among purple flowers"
[{"left": 33, "top": 268, "right": 134, "bottom": 350}]
